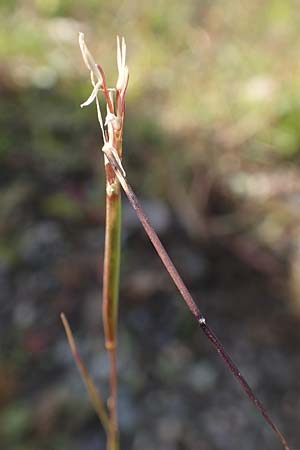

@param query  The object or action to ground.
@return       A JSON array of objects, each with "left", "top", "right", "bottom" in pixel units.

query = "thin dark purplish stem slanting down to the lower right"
[{"left": 103, "top": 148, "right": 289, "bottom": 450}]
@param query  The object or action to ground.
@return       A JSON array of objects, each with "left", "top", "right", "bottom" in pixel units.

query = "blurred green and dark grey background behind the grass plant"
[{"left": 0, "top": 0, "right": 300, "bottom": 450}]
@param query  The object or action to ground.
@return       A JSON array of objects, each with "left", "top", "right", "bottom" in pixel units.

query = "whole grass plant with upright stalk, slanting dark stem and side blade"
[{"left": 61, "top": 33, "right": 289, "bottom": 450}]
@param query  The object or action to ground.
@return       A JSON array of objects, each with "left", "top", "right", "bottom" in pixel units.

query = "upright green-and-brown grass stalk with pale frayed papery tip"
[{"left": 79, "top": 33, "right": 129, "bottom": 450}]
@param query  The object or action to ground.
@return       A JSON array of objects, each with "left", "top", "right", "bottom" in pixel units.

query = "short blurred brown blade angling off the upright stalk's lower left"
[{"left": 60, "top": 313, "right": 109, "bottom": 432}]
